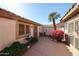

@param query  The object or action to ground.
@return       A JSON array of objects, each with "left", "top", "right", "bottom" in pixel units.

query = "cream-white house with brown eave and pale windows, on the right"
[{"left": 61, "top": 3, "right": 79, "bottom": 51}]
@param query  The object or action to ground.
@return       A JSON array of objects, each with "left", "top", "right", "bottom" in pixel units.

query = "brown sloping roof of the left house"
[{"left": 0, "top": 8, "right": 42, "bottom": 25}]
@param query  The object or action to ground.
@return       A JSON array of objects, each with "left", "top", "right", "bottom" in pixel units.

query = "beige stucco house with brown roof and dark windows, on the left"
[{"left": 0, "top": 8, "right": 41, "bottom": 50}]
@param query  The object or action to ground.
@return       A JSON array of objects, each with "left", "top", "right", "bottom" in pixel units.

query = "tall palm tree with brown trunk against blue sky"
[{"left": 48, "top": 12, "right": 60, "bottom": 30}]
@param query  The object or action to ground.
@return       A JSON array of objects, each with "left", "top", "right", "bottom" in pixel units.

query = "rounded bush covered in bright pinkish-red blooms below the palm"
[{"left": 52, "top": 30, "right": 64, "bottom": 42}]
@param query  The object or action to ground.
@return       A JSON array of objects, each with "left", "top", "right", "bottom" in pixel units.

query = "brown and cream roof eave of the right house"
[{"left": 60, "top": 4, "right": 79, "bottom": 22}]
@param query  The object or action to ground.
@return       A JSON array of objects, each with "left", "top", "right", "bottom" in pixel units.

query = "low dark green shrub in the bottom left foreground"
[{"left": 1, "top": 42, "right": 27, "bottom": 56}]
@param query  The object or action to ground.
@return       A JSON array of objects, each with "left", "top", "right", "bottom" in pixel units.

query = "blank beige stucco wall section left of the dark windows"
[{"left": 0, "top": 18, "right": 16, "bottom": 50}]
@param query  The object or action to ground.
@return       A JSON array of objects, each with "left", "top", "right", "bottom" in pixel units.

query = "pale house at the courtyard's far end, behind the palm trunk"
[{"left": 41, "top": 22, "right": 64, "bottom": 35}]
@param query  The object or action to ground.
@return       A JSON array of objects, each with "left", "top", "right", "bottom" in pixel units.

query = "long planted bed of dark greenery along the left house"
[{"left": 0, "top": 38, "right": 38, "bottom": 56}]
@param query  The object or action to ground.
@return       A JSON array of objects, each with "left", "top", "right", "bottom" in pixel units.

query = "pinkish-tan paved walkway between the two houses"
[{"left": 24, "top": 37, "right": 72, "bottom": 56}]
